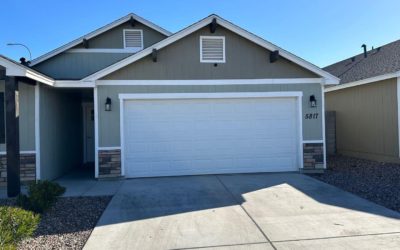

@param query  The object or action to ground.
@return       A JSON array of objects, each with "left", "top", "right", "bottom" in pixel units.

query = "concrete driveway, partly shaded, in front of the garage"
[{"left": 85, "top": 173, "right": 400, "bottom": 250}]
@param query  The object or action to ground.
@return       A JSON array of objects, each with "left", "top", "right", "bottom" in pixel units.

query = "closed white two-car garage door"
[{"left": 122, "top": 95, "right": 299, "bottom": 177}]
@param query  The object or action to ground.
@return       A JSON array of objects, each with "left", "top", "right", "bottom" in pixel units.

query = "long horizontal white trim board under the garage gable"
[{"left": 95, "top": 78, "right": 324, "bottom": 86}]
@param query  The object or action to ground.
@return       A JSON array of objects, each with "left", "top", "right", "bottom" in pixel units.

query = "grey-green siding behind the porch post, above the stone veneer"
[{"left": 0, "top": 81, "right": 35, "bottom": 151}]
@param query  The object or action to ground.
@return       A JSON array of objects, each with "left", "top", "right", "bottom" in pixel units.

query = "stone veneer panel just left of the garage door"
[{"left": 99, "top": 149, "right": 121, "bottom": 178}]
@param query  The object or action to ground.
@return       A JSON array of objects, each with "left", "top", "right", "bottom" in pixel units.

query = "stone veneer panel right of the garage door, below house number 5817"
[{"left": 303, "top": 143, "right": 324, "bottom": 171}]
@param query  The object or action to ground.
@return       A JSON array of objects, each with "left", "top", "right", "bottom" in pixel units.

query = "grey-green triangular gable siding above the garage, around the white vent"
[{"left": 104, "top": 26, "right": 318, "bottom": 80}]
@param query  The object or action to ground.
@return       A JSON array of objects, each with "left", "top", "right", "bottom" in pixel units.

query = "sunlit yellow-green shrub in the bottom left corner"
[{"left": 0, "top": 207, "right": 40, "bottom": 249}]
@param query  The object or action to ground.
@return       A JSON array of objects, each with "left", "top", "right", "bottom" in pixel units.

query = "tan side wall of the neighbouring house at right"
[{"left": 325, "top": 78, "right": 399, "bottom": 164}]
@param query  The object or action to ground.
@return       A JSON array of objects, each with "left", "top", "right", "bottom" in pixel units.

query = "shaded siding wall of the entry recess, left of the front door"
[{"left": 40, "top": 85, "right": 83, "bottom": 179}]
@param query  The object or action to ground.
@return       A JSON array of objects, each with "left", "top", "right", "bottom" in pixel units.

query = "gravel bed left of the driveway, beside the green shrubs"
[{"left": 0, "top": 196, "right": 111, "bottom": 250}]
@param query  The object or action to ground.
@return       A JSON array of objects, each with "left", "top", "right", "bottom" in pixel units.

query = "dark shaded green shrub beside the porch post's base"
[{"left": 17, "top": 181, "right": 65, "bottom": 213}]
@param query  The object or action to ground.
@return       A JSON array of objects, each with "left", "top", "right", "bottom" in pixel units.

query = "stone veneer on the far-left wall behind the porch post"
[{"left": 0, "top": 153, "right": 36, "bottom": 186}]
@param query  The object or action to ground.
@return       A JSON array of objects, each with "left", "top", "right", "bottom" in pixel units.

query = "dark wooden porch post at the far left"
[{"left": 5, "top": 76, "right": 21, "bottom": 197}]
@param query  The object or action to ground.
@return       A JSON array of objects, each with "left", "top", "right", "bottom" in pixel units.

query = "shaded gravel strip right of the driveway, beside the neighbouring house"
[{"left": 310, "top": 156, "right": 400, "bottom": 212}]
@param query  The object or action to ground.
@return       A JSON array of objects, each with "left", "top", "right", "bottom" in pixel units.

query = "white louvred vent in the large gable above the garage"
[{"left": 200, "top": 36, "right": 225, "bottom": 63}]
